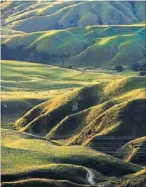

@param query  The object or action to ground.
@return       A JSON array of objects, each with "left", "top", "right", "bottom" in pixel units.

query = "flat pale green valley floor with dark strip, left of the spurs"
[{"left": 1, "top": 61, "right": 122, "bottom": 128}]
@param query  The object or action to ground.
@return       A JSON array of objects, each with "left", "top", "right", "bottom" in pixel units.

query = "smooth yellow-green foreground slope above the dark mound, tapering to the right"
[{"left": 2, "top": 129, "right": 141, "bottom": 176}]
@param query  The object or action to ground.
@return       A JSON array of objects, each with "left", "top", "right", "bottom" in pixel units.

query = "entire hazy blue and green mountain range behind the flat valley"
[{"left": 2, "top": 1, "right": 145, "bottom": 68}]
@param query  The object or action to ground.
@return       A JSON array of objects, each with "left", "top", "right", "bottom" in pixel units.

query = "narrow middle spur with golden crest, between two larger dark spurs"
[{"left": 47, "top": 89, "right": 145, "bottom": 143}]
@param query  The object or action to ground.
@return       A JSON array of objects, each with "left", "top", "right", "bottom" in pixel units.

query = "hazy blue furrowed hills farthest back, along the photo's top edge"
[{"left": 2, "top": 1, "right": 145, "bottom": 32}]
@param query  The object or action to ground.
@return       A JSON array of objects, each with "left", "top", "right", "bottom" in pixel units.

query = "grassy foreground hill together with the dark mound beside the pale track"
[{"left": 2, "top": 129, "right": 141, "bottom": 178}]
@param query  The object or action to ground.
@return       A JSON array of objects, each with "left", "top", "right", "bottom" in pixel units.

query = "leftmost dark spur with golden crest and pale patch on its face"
[{"left": 15, "top": 84, "right": 101, "bottom": 135}]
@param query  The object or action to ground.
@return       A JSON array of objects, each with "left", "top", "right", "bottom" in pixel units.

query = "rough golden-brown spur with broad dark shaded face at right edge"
[{"left": 69, "top": 98, "right": 146, "bottom": 146}]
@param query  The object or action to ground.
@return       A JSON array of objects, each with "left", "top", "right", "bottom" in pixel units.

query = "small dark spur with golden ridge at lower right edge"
[{"left": 115, "top": 136, "right": 146, "bottom": 165}]
